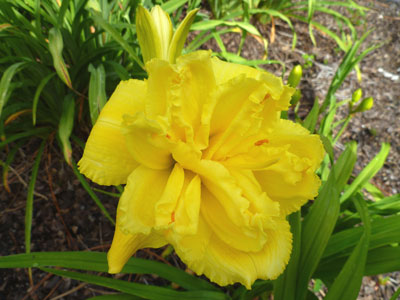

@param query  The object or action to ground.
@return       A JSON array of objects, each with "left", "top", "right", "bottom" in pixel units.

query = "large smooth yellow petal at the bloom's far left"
[{"left": 78, "top": 79, "right": 147, "bottom": 185}]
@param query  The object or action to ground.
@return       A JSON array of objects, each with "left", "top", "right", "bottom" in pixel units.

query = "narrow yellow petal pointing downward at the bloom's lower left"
[{"left": 107, "top": 222, "right": 167, "bottom": 274}]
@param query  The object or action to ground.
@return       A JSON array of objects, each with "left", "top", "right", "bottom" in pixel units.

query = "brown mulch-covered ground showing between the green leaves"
[{"left": 0, "top": 0, "right": 400, "bottom": 300}]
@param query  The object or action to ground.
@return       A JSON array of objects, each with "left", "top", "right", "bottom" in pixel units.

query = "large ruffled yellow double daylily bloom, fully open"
[{"left": 79, "top": 51, "right": 324, "bottom": 288}]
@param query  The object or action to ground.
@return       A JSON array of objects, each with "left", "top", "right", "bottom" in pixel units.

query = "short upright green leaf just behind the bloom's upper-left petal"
[{"left": 89, "top": 64, "right": 107, "bottom": 125}]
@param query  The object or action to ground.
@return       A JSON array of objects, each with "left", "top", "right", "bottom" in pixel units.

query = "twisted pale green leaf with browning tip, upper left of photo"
[{"left": 49, "top": 28, "right": 72, "bottom": 89}]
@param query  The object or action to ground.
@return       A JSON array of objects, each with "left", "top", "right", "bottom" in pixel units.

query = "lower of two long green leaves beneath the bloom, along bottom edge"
[{"left": 41, "top": 268, "right": 228, "bottom": 300}]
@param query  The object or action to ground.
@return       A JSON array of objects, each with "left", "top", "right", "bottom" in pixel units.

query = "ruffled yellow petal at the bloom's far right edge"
[{"left": 254, "top": 120, "right": 324, "bottom": 215}]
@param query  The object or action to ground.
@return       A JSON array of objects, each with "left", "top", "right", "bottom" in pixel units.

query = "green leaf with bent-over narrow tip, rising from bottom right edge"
[{"left": 325, "top": 195, "right": 371, "bottom": 300}]
